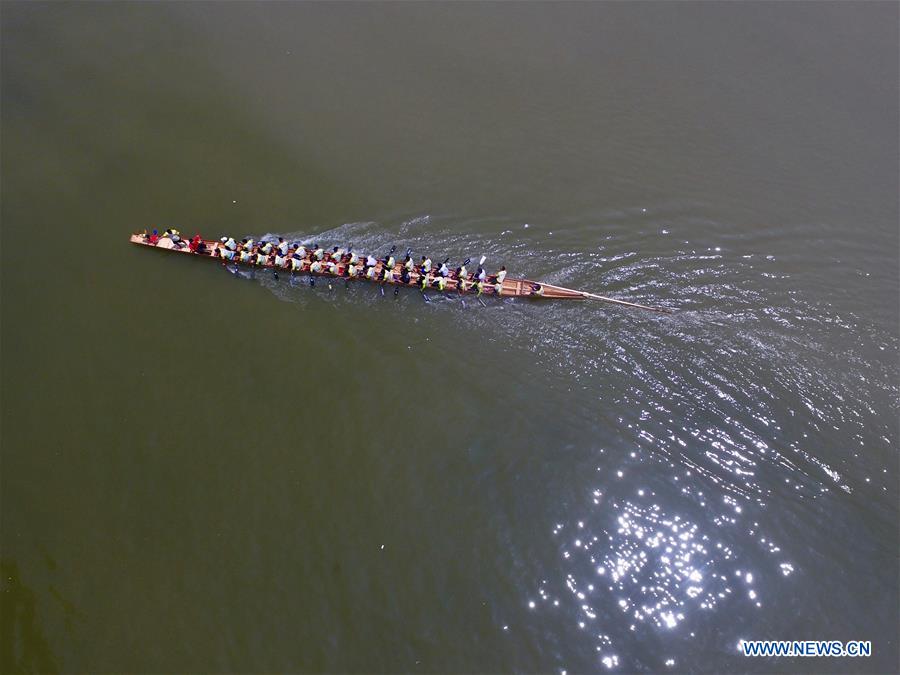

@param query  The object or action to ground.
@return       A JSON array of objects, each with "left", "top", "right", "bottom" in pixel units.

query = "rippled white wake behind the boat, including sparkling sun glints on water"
[{"left": 243, "top": 214, "right": 900, "bottom": 670}]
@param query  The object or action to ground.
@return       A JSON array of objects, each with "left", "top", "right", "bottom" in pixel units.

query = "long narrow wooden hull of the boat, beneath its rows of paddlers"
[{"left": 131, "top": 234, "right": 672, "bottom": 313}]
